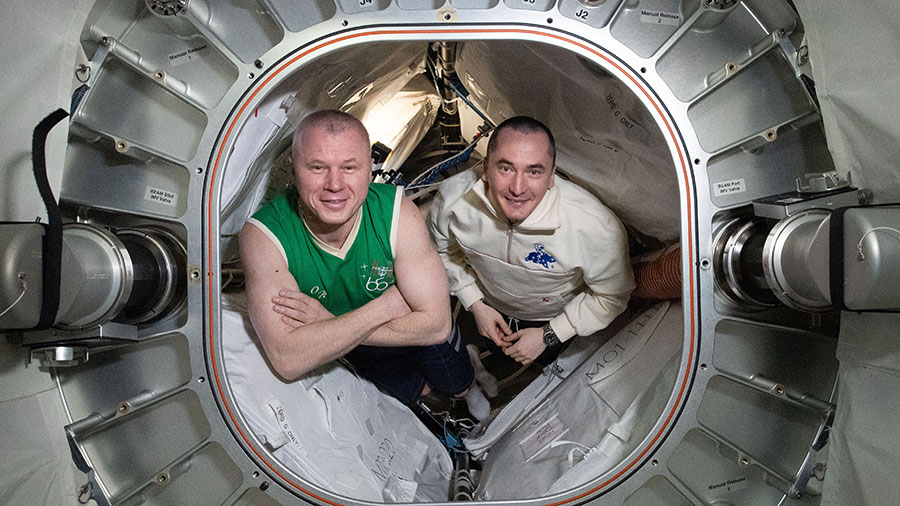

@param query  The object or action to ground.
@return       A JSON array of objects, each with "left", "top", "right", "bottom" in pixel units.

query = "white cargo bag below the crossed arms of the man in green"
[{"left": 222, "top": 302, "right": 452, "bottom": 502}]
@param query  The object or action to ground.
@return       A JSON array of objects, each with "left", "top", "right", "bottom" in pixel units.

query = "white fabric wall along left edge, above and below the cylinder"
[{"left": 0, "top": 0, "right": 93, "bottom": 506}]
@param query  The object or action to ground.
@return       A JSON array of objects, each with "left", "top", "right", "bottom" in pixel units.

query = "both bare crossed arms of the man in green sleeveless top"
[{"left": 240, "top": 199, "right": 450, "bottom": 380}]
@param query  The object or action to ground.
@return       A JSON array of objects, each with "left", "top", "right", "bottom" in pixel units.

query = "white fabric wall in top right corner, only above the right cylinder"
[{"left": 795, "top": 0, "right": 900, "bottom": 202}]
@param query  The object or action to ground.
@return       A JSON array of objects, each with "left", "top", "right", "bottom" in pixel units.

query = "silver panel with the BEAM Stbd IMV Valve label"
[{"left": 60, "top": 139, "right": 190, "bottom": 219}]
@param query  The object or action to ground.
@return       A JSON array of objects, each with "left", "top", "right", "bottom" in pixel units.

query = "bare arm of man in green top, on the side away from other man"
[{"left": 240, "top": 224, "right": 409, "bottom": 380}]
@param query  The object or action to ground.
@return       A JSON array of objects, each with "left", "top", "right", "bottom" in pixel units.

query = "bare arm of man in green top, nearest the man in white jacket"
[{"left": 365, "top": 198, "right": 450, "bottom": 346}]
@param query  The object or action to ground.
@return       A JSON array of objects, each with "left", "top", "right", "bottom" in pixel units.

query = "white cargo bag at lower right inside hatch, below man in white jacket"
[{"left": 466, "top": 302, "right": 683, "bottom": 500}]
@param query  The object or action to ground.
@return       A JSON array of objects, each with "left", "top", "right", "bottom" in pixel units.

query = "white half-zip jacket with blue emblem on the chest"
[{"left": 428, "top": 170, "right": 634, "bottom": 341}]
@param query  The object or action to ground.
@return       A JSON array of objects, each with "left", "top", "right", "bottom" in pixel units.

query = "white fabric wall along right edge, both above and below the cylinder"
[{"left": 795, "top": 4, "right": 900, "bottom": 506}]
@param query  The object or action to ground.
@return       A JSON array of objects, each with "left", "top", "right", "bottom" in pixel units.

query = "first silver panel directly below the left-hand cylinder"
[{"left": 57, "top": 334, "right": 191, "bottom": 420}]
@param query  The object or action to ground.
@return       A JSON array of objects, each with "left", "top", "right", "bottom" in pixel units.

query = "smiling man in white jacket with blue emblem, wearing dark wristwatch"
[{"left": 428, "top": 116, "right": 634, "bottom": 364}]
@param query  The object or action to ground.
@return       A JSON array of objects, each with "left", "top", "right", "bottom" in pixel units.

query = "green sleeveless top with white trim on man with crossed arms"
[{"left": 252, "top": 183, "right": 402, "bottom": 315}]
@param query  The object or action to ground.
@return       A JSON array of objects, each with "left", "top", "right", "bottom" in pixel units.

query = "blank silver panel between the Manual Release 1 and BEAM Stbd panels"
[{"left": 74, "top": 59, "right": 206, "bottom": 161}]
